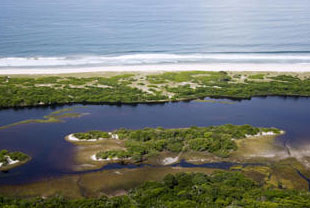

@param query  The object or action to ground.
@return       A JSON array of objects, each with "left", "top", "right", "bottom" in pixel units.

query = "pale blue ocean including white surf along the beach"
[{"left": 0, "top": 0, "right": 310, "bottom": 70}]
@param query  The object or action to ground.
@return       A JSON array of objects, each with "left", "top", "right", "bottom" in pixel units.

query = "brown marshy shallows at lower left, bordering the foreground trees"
[{"left": 0, "top": 167, "right": 216, "bottom": 198}]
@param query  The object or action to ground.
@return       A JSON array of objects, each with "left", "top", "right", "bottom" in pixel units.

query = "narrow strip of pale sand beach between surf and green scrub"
[{"left": 0, "top": 64, "right": 310, "bottom": 75}]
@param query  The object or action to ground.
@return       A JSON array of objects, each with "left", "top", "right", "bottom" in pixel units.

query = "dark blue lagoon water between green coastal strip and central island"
[{"left": 0, "top": 97, "right": 310, "bottom": 184}]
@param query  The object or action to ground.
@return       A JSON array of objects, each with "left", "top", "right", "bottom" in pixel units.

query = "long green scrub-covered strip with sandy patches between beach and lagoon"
[{"left": 0, "top": 71, "right": 310, "bottom": 108}]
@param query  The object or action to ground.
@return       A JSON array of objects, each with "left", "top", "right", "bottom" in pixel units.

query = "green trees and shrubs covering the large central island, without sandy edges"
[{"left": 74, "top": 124, "right": 280, "bottom": 161}]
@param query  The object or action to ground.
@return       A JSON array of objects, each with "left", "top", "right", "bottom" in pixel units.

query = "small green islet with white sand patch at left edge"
[{"left": 0, "top": 150, "right": 31, "bottom": 171}]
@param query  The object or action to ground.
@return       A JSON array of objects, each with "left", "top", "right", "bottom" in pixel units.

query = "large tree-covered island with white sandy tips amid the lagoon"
[{"left": 66, "top": 124, "right": 283, "bottom": 165}]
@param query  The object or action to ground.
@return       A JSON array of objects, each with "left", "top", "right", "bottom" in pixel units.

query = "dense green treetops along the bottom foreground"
[{"left": 0, "top": 171, "right": 310, "bottom": 208}]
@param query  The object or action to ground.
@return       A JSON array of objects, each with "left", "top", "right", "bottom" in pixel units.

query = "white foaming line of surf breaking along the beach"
[{"left": 0, "top": 53, "right": 310, "bottom": 68}]
